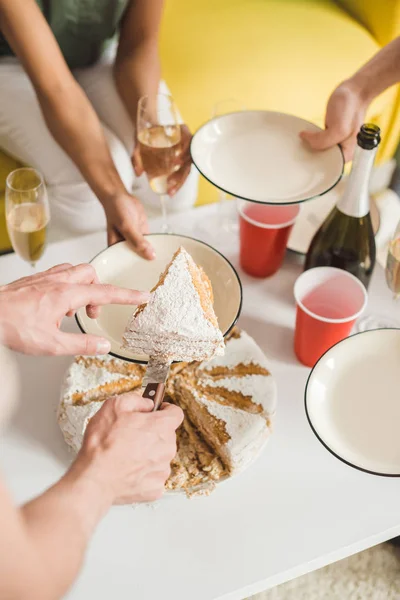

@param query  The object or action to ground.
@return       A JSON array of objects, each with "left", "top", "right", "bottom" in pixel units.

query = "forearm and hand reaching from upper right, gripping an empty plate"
[{"left": 300, "top": 37, "right": 400, "bottom": 161}]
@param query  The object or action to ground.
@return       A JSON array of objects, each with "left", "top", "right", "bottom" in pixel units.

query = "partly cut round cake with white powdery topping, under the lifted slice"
[{"left": 58, "top": 329, "right": 276, "bottom": 495}]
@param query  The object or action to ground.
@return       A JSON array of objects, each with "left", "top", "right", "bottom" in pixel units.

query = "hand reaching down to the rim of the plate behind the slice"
[{"left": 102, "top": 192, "right": 156, "bottom": 260}]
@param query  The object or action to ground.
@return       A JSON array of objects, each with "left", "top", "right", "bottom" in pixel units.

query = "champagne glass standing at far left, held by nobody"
[{"left": 6, "top": 168, "right": 50, "bottom": 268}]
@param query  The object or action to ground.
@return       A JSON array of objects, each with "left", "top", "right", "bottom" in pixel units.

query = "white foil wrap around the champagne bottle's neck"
[{"left": 337, "top": 146, "right": 377, "bottom": 218}]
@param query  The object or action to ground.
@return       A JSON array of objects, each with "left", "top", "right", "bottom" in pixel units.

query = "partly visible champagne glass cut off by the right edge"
[{"left": 357, "top": 216, "right": 400, "bottom": 331}]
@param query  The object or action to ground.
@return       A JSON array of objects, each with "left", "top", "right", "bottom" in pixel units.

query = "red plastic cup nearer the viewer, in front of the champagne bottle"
[{"left": 294, "top": 267, "right": 368, "bottom": 367}]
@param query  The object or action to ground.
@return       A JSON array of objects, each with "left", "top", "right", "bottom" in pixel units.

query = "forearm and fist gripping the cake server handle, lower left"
[{"left": 0, "top": 393, "right": 183, "bottom": 600}]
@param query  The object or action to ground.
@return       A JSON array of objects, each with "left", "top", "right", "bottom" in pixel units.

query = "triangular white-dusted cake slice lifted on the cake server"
[{"left": 123, "top": 247, "right": 224, "bottom": 361}]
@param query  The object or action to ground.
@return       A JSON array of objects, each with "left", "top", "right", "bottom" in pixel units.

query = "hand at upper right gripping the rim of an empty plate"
[{"left": 300, "top": 80, "right": 368, "bottom": 162}]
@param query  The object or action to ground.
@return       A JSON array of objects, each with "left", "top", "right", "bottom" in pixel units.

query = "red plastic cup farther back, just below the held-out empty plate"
[{"left": 238, "top": 200, "right": 300, "bottom": 277}]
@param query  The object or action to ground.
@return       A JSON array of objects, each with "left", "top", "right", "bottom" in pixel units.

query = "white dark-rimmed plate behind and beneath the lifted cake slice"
[{"left": 76, "top": 234, "right": 242, "bottom": 363}]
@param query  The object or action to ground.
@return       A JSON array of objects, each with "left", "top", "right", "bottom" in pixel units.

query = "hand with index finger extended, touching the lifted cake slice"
[{"left": 0, "top": 264, "right": 149, "bottom": 355}]
